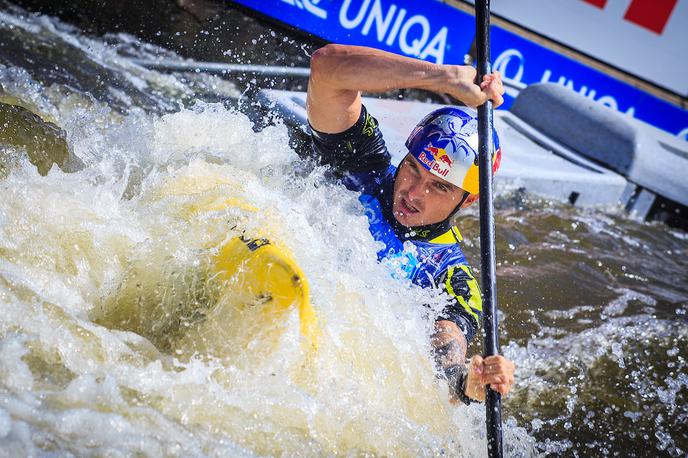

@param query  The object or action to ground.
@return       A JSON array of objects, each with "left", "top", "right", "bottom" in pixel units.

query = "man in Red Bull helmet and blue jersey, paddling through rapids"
[{"left": 307, "top": 44, "right": 514, "bottom": 403}]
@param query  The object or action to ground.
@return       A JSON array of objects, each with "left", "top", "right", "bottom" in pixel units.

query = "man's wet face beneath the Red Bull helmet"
[{"left": 392, "top": 154, "right": 472, "bottom": 227}]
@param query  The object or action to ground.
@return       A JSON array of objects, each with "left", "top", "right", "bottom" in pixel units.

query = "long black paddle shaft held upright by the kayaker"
[{"left": 475, "top": 0, "right": 503, "bottom": 457}]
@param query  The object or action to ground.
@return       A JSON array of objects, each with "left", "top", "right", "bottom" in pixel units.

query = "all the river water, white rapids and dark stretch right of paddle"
[{"left": 0, "top": 5, "right": 688, "bottom": 456}]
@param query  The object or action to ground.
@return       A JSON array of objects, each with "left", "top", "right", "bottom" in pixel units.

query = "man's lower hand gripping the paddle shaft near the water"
[{"left": 464, "top": 355, "right": 514, "bottom": 401}]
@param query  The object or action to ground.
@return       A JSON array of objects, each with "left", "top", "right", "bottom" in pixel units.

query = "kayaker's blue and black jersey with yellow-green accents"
[{"left": 311, "top": 107, "right": 482, "bottom": 341}]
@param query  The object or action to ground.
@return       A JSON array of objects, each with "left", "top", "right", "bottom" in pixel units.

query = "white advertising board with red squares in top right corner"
[{"left": 491, "top": 0, "right": 688, "bottom": 97}]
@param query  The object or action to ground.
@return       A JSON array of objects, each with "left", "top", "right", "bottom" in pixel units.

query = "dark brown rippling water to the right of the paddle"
[{"left": 466, "top": 199, "right": 688, "bottom": 456}]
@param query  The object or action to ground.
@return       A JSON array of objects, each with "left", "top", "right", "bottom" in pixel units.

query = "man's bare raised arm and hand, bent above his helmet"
[{"left": 306, "top": 44, "right": 504, "bottom": 133}]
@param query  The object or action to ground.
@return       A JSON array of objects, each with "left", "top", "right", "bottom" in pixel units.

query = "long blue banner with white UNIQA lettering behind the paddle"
[{"left": 232, "top": 0, "right": 688, "bottom": 140}]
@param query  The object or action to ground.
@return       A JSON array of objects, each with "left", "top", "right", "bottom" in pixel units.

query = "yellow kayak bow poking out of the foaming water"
[{"left": 178, "top": 237, "right": 318, "bottom": 354}]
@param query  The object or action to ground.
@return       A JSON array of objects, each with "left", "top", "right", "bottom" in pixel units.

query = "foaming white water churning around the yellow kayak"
[{"left": 0, "top": 38, "right": 529, "bottom": 450}]
